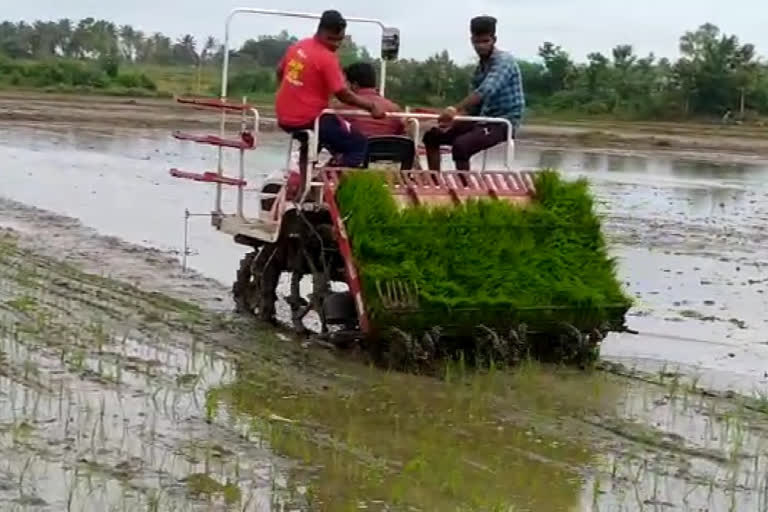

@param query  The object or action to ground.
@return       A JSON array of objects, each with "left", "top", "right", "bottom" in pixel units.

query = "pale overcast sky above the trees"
[{"left": 0, "top": 0, "right": 768, "bottom": 63}]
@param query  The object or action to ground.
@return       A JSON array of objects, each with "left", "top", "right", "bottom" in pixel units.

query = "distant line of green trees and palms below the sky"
[{"left": 0, "top": 18, "right": 768, "bottom": 119}]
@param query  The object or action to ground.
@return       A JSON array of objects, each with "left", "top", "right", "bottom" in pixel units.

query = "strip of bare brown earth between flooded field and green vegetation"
[{"left": 6, "top": 91, "right": 768, "bottom": 158}]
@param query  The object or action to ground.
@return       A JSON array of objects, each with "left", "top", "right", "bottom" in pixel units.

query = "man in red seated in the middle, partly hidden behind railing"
[{"left": 342, "top": 62, "right": 405, "bottom": 137}]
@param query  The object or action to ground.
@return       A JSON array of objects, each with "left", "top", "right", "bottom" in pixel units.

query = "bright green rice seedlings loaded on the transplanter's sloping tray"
[{"left": 337, "top": 171, "right": 630, "bottom": 334}]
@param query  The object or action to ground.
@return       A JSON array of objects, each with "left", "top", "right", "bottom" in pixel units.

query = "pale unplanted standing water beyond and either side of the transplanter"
[{"left": 0, "top": 129, "right": 768, "bottom": 391}]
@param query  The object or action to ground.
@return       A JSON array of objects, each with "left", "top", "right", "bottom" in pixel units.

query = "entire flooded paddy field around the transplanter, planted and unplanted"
[{"left": 0, "top": 114, "right": 768, "bottom": 511}]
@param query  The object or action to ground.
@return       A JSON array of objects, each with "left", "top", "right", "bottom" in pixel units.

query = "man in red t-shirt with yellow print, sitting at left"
[{"left": 275, "top": 11, "right": 385, "bottom": 167}]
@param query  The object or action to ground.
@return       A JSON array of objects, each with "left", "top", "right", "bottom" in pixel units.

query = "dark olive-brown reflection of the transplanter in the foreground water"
[{"left": 209, "top": 361, "right": 616, "bottom": 512}]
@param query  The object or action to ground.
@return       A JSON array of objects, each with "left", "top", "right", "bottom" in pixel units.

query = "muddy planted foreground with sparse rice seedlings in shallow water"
[{"left": 0, "top": 233, "right": 768, "bottom": 511}]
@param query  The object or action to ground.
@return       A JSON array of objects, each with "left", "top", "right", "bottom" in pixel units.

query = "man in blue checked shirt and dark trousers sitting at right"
[{"left": 424, "top": 16, "right": 525, "bottom": 171}]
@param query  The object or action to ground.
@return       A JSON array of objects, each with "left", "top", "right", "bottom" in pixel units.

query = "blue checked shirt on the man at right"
[{"left": 471, "top": 49, "right": 525, "bottom": 126}]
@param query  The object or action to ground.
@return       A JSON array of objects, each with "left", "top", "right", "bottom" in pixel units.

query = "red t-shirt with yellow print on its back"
[{"left": 275, "top": 37, "right": 347, "bottom": 127}]
